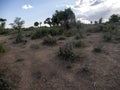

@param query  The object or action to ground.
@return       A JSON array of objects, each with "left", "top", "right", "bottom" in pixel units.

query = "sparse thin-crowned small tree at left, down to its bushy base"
[{"left": 10, "top": 17, "right": 25, "bottom": 43}]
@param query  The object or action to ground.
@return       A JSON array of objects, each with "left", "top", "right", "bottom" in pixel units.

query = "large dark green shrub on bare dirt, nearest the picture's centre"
[{"left": 58, "top": 43, "right": 77, "bottom": 61}]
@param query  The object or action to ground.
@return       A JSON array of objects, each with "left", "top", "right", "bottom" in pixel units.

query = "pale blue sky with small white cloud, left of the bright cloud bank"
[{"left": 0, "top": 0, "right": 75, "bottom": 27}]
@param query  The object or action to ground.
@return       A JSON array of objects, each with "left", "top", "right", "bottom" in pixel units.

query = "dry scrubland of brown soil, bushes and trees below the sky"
[{"left": 0, "top": 8, "right": 120, "bottom": 90}]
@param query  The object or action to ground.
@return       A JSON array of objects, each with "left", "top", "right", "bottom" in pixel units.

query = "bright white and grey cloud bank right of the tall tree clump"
[{"left": 67, "top": 0, "right": 120, "bottom": 21}]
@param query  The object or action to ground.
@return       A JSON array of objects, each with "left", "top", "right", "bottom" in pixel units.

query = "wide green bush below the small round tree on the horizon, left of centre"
[{"left": 31, "top": 28, "right": 50, "bottom": 39}]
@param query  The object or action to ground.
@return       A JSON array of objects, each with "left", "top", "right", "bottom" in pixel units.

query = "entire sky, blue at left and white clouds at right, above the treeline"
[{"left": 0, "top": 0, "right": 120, "bottom": 27}]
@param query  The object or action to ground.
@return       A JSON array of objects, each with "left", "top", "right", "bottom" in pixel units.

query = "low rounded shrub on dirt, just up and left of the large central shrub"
[{"left": 43, "top": 35, "right": 57, "bottom": 45}]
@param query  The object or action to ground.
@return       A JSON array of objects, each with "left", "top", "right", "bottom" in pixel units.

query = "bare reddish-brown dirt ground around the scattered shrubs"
[{"left": 0, "top": 33, "right": 120, "bottom": 90}]
